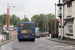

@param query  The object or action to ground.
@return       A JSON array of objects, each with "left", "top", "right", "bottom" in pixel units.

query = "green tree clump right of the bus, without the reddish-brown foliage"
[{"left": 31, "top": 13, "right": 55, "bottom": 31}]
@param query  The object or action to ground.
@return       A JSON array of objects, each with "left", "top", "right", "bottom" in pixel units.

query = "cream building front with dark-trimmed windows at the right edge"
[{"left": 63, "top": 0, "right": 75, "bottom": 39}]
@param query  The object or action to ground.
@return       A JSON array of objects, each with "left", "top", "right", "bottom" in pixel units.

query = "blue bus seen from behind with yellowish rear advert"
[{"left": 17, "top": 22, "right": 35, "bottom": 41}]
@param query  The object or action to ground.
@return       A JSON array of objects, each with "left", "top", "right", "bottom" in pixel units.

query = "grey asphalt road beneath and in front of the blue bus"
[{"left": 0, "top": 38, "right": 75, "bottom": 50}]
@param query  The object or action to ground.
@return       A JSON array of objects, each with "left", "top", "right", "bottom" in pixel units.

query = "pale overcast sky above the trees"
[{"left": 0, "top": 0, "right": 58, "bottom": 20}]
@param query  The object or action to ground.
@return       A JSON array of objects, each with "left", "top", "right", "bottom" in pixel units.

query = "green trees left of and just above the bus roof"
[{"left": 0, "top": 14, "right": 29, "bottom": 26}]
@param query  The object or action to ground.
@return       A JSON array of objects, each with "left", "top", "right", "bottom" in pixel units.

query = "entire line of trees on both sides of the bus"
[{"left": 0, "top": 13, "right": 58, "bottom": 32}]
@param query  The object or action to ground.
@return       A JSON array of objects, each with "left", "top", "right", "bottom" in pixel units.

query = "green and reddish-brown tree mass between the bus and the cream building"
[{"left": 31, "top": 13, "right": 58, "bottom": 32}]
